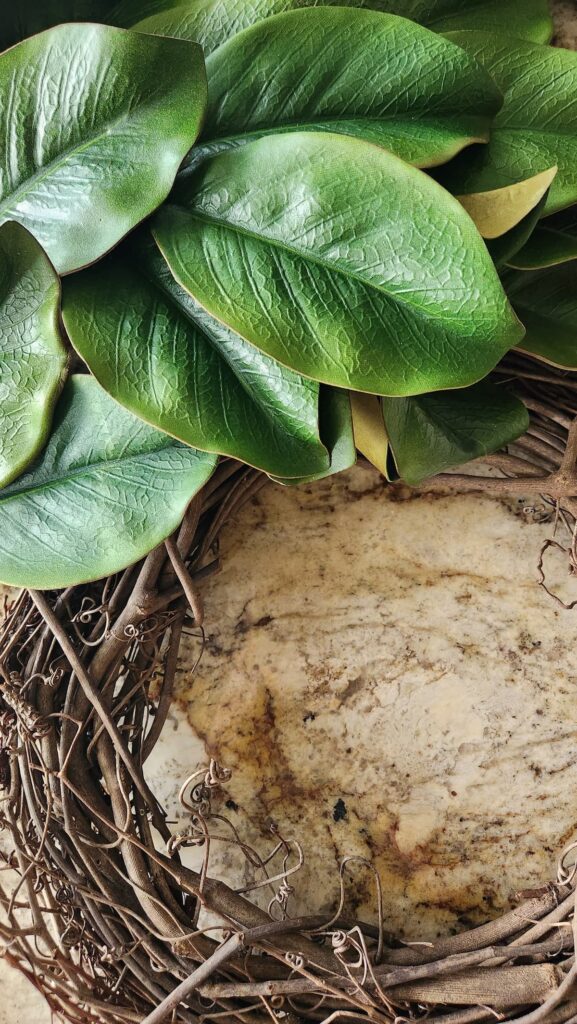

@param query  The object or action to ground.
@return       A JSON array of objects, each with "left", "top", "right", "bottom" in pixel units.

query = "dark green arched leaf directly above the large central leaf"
[{"left": 182, "top": 7, "right": 502, "bottom": 167}]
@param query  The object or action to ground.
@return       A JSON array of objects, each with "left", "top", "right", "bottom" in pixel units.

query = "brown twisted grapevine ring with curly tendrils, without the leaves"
[{"left": 0, "top": 356, "right": 577, "bottom": 1024}]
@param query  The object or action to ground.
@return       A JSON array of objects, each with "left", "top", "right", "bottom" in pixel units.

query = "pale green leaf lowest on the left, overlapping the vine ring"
[{"left": 0, "top": 376, "right": 216, "bottom": 590}]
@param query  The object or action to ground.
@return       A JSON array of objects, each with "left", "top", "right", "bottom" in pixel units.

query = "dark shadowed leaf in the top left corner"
[{"left": 0, "top": 0, "right": 117, "bottom": 50}]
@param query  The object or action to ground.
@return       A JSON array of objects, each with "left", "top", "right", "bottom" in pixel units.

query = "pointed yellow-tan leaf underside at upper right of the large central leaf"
[{"left": 457, "top": 167, "right": 557, "bottom": 239}]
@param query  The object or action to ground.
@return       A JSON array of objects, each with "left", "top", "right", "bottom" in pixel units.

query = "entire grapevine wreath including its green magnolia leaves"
[{"left": 0, "top": 0, "right": 577, "bottom": 1024}]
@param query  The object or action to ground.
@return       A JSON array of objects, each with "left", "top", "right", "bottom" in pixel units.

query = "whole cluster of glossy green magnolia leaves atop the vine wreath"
[{"left": 0, "top": 0, "right": 577, "bottom": 588}]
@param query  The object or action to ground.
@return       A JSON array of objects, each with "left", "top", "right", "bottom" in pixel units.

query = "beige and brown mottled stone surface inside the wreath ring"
[{"left": 146, "top": 467, "right": 577, "bottom": 939}]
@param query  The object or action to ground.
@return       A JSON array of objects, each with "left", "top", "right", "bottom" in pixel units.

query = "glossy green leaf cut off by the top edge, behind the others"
[{"left": 113, "top": 0, "right": 552, "bottom": 53}]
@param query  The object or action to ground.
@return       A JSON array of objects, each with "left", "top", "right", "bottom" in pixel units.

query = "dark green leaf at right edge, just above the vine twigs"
[{"left": 503, "top": 262, "right": 577, "bottom": 370}]
